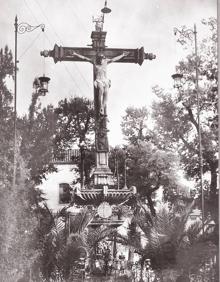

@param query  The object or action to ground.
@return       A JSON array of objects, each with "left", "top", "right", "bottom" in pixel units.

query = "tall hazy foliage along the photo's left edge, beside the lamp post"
[{"left": 0, "top": 46, "right": 43, "bottom": 282}]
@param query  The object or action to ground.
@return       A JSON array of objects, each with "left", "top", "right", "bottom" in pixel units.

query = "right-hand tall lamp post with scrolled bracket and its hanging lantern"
[{"left": 172, "top": 24, "right": 205, "bottom": 234}]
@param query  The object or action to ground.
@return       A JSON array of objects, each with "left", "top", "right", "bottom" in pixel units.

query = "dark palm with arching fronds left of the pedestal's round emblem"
[{"left": 37, "top": 205, "right": 97, "bottom": 280}]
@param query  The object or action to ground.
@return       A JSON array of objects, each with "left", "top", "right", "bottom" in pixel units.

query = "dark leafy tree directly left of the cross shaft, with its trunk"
[{"left": 54, "top": 97, "right": 95, "bottom": 187}]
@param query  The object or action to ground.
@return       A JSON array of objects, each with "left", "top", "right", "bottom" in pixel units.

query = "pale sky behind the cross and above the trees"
[{"left": 0, "top": 0, "right": 217, "bottom": 146}]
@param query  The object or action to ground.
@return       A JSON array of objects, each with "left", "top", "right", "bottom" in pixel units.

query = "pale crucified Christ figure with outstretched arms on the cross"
[{"left": 72, "top": 52, "right": 129, "bottom": 116}]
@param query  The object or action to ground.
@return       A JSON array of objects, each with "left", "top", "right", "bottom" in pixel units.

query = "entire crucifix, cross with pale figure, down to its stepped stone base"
[{"left": 41, "top": 1, "right": 156, "bottom": 200}]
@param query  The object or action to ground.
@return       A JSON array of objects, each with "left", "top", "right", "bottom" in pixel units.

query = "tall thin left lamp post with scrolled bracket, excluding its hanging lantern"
[{"left": 12, "top": 16, "right": 45, "bottom": 189}]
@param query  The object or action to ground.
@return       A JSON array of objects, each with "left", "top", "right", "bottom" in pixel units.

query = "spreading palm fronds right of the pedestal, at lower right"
[{"left": 131, "top": 203, "right": 199, "bottom": 267}]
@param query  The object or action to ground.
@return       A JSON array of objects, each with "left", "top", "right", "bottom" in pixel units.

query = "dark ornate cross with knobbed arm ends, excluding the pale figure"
[{"left": 41, "top": 16, "right": 156, "bottom": 185}]
